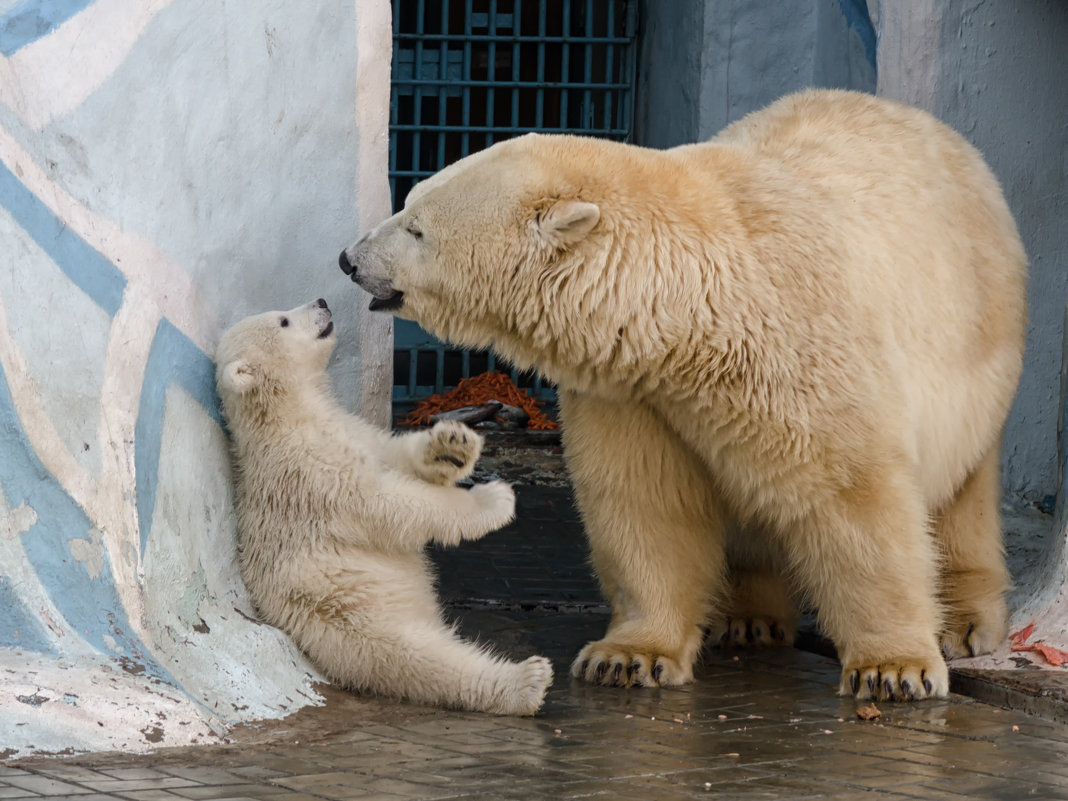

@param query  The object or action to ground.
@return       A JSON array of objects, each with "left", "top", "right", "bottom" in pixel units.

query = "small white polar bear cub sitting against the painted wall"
[{"left": 217, "top": 299, "right": 552, "bottom": 714}]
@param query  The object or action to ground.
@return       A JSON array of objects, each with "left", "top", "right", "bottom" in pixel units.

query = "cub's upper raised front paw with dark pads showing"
[{"left": 384, "top": 420, "right": 483, "bottom": 486}]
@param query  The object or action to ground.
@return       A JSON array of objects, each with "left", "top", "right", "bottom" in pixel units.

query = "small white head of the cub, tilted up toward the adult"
[{"left": 216, "top": 298, "right": 336, "bottom": 407}]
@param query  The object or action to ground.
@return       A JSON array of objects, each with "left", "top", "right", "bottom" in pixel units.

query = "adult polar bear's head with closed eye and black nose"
[{"left": 340, "top": 135, "right": 613, "bottom": 347}]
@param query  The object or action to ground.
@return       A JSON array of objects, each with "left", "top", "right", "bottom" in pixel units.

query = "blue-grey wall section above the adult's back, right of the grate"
[{"left": 635, "top": 0, "right": 876, "bottom": 147}]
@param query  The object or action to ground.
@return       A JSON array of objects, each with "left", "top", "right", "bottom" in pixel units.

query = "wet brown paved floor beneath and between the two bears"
[{"left": 0, "top": 442, "right": 1068, "bottom": 801}]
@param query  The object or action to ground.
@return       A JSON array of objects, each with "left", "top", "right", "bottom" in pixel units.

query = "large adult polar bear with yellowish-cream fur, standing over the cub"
[{"left": 341, "top": 91, "right": 1026, "bottom": 698}]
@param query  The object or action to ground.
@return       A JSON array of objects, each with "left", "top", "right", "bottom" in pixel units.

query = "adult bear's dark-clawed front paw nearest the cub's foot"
[{"left": 571, "top": 640, "right": 693, "bottom": 687}]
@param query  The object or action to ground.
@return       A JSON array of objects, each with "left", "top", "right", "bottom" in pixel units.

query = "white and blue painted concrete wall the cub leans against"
[{"left": 0, "top": 0, "right": 390, "bottom": 757}]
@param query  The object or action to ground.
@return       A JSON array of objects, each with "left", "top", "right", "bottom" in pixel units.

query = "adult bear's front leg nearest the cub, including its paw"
[{"left": 560, "top": 392, "right": 725, "bottom": 687}]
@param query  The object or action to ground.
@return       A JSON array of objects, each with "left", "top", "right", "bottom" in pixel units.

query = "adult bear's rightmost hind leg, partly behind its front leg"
[{"left": 935, "top": 441, "right": 1010, "bottom": 659}]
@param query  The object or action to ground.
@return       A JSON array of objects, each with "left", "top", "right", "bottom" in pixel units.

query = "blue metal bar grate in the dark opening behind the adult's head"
[{"left": 389, "top": 0, "right": 639, "bottom": 405}]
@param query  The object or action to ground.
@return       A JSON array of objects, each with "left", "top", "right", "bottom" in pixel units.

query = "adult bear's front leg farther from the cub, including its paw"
[{"left": 787, "top": 459, "right": 949, "bottom": 701}]
